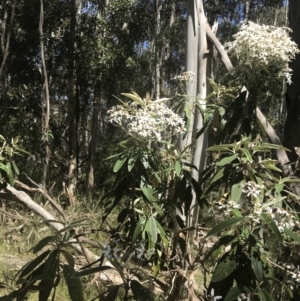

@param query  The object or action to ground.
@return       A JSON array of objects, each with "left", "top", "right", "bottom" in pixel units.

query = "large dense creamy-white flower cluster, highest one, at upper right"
[{"left": 225, "top": 22, "right": 299, "bottom": 83}]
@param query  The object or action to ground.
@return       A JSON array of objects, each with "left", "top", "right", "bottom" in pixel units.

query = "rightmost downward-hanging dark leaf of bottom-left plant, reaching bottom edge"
[{"left": 63, "top": 265, "right": 84, "bottom": 301}]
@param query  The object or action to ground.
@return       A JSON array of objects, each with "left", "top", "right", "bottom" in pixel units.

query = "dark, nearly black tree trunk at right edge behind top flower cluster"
[{"left": 283, "top": 0, "right": 300, "bottom": 162}]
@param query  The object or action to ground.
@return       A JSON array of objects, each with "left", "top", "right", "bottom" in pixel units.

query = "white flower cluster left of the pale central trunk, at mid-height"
[{"left": 107, "top": 102, "right": 186, "bottom": 141}]
